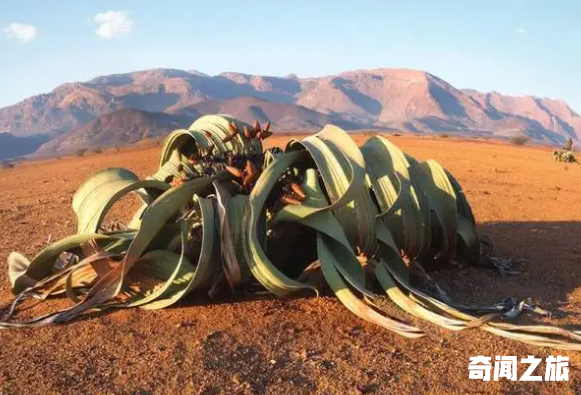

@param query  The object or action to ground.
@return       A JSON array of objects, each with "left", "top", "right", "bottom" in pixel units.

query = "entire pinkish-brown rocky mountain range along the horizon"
[{"left": 0, "top": 69, "right": 581, "bottom": 159}]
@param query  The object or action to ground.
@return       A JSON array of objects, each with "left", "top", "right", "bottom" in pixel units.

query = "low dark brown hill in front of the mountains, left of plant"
[{"left": 36, "top": 109, "right": 191, "bottom": 156}]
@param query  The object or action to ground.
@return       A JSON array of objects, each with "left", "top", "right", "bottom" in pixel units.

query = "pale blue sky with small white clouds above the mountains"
[{"left": 0, "top": 0, "right": 581, "bottom": 112}]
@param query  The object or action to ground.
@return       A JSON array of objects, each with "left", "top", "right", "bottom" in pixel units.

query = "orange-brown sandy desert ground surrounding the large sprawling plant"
[{"left": 0, "top": 136, "right": 581, "bottom": 395}]
